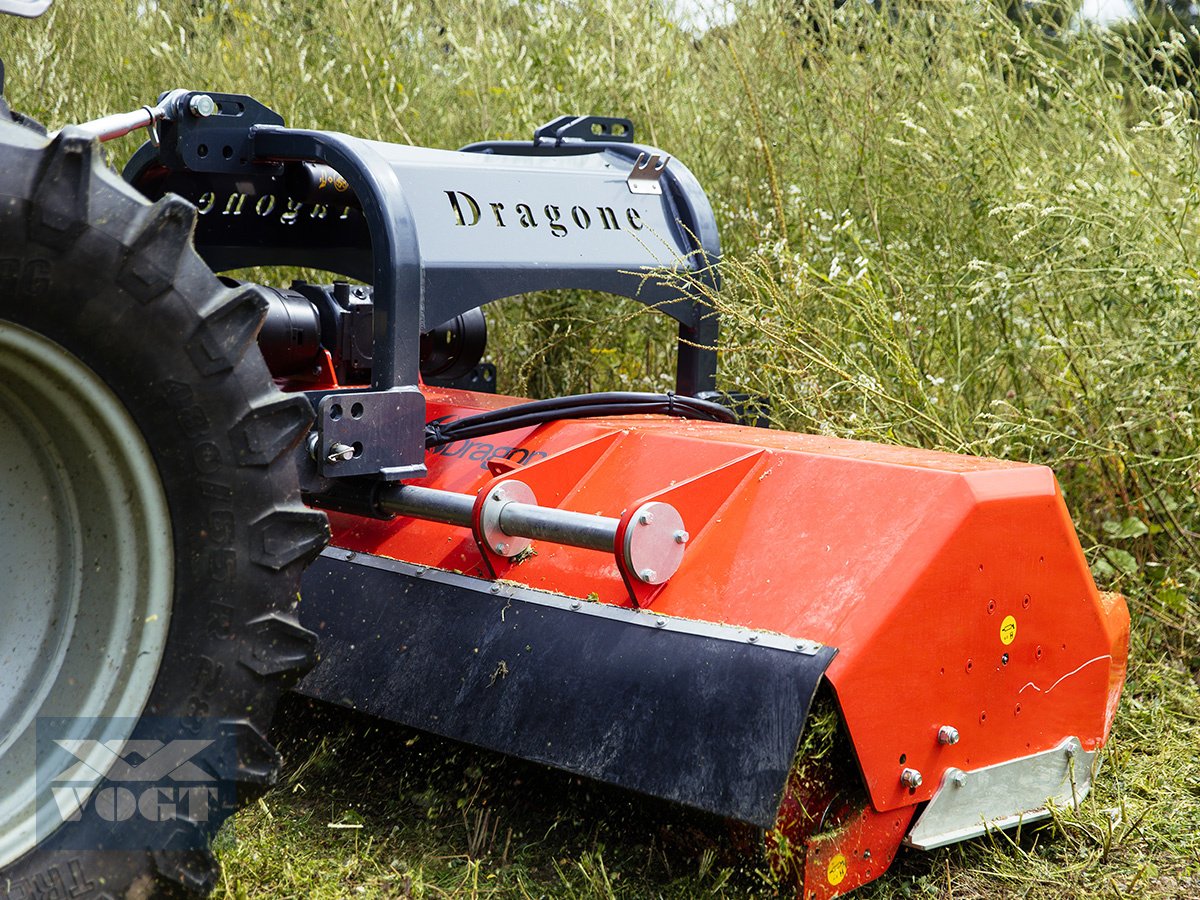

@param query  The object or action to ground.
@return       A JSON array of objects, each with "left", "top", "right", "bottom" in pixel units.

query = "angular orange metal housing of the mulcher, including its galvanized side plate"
[{"left": 297, "top": 389, "right": 1129, "bottom": 896}]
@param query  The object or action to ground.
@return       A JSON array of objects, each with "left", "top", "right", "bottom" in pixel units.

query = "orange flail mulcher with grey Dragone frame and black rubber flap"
[{"left": 122, "top": 102, "right": 1129, "bottom": 898}]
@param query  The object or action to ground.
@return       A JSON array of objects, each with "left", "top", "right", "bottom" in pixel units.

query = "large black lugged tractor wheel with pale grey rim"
[{"left": 0, "top": 121, "right": 328, "bottom": 900}]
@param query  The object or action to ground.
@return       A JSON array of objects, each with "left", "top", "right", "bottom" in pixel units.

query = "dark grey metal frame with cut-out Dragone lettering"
[{"left": 125, "top": 94, "right": 720, "bottom": 480}]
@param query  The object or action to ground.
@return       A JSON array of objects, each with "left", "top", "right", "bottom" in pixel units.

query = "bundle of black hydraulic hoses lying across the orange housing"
[{"left": 425, "top": 391, "right": 737, "bottom": 449}]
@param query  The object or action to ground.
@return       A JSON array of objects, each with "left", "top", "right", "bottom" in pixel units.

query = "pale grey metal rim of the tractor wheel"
[{"left": 0, "top": 320, "right": 174, "bottom": 868}]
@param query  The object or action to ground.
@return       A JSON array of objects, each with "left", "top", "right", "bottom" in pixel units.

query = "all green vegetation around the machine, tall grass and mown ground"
[{"left": 0, "top": 0, "right": 1200, "bottom": 898}]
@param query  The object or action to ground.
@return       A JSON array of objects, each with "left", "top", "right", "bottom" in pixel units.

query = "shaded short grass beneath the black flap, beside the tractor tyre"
[{"left": 210, "top": 698, "right": 754, "bottom": 898}]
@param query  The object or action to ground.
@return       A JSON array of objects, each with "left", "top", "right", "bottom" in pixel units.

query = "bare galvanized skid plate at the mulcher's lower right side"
[{"left": 905, "top": 738, "right": 1096, "bottom": 850}]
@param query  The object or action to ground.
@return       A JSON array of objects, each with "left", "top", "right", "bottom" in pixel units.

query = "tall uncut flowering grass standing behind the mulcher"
[{"left": 0, "top": 0, "right": 1200, "bottom": 895}]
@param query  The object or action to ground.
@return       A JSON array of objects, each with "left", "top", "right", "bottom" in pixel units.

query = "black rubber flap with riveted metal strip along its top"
[{"left": 298, "top": 548, "right": 836, "bottom": 828}]
